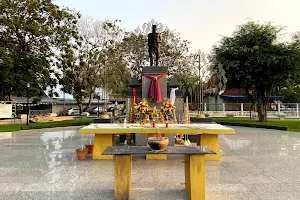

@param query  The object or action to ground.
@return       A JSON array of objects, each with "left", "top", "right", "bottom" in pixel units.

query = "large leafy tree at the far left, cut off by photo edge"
[{"left": 0, "top": 0, "right": 79, "bottom": 101}]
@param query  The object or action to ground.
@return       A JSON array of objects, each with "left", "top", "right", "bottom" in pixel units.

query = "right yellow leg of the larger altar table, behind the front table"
[{"left": 198, "top": 134, "right": 220, "bottom": 160}]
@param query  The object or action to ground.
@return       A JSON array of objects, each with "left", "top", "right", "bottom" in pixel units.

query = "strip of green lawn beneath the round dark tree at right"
[{"left": 213, "top": 118, "right": 300, "bottom": 132}]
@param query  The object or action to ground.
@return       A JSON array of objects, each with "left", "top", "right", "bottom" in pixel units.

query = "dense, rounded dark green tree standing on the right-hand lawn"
[{"left": 213, "top": 22, "right": 299, "bottom": 122}]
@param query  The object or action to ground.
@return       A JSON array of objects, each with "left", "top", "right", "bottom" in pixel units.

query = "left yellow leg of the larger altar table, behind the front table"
[{"left": 93, "top": 134, "right": 115, "bottom": 160}]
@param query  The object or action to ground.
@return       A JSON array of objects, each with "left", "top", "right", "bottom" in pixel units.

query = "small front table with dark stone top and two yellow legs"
[{"left": 102, "top": 146, "right": 215, "bottom": 200}]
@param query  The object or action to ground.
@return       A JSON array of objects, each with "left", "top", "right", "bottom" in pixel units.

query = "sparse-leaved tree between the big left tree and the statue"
[{"left": 57, "top": 17, "right": 126, "bottom": 113}]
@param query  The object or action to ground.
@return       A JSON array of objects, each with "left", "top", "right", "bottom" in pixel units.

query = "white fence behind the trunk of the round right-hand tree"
[{"left": 191, "top": 103, "right": 300, "bottom": 117}]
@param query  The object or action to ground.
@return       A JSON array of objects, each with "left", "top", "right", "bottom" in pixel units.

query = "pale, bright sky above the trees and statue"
[{"left": 54, "top": 0, "right": 300, "bottom": 53}]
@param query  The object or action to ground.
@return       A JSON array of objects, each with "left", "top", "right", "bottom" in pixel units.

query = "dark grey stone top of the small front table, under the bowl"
[{"left": 102, "top": 146, "right": 215, "bottom": 155}]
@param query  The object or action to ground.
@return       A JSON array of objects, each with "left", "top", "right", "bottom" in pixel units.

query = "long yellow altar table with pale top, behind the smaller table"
[{"left": 79, "top": 123, "right": 235, "bottom": 160}]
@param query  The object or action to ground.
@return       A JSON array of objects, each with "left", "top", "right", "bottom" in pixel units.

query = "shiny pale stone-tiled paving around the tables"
[{"left": 0, "top": 127, "right": 300, "bottom": 200}]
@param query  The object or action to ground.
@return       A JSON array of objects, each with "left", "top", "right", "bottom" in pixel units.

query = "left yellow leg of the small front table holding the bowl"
[{"left": 115, "top": 155, "right": 132, "bottom": 200}]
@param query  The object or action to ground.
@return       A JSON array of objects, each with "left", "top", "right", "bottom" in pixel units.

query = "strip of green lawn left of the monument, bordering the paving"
[{"left": 0, "top": 119, "right": 94, "bottom": 132}]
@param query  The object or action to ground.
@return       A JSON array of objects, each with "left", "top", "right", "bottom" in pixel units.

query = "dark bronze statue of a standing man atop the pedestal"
[{"left": 148, "top": 25, "right": 161, "bottom": 66}]
